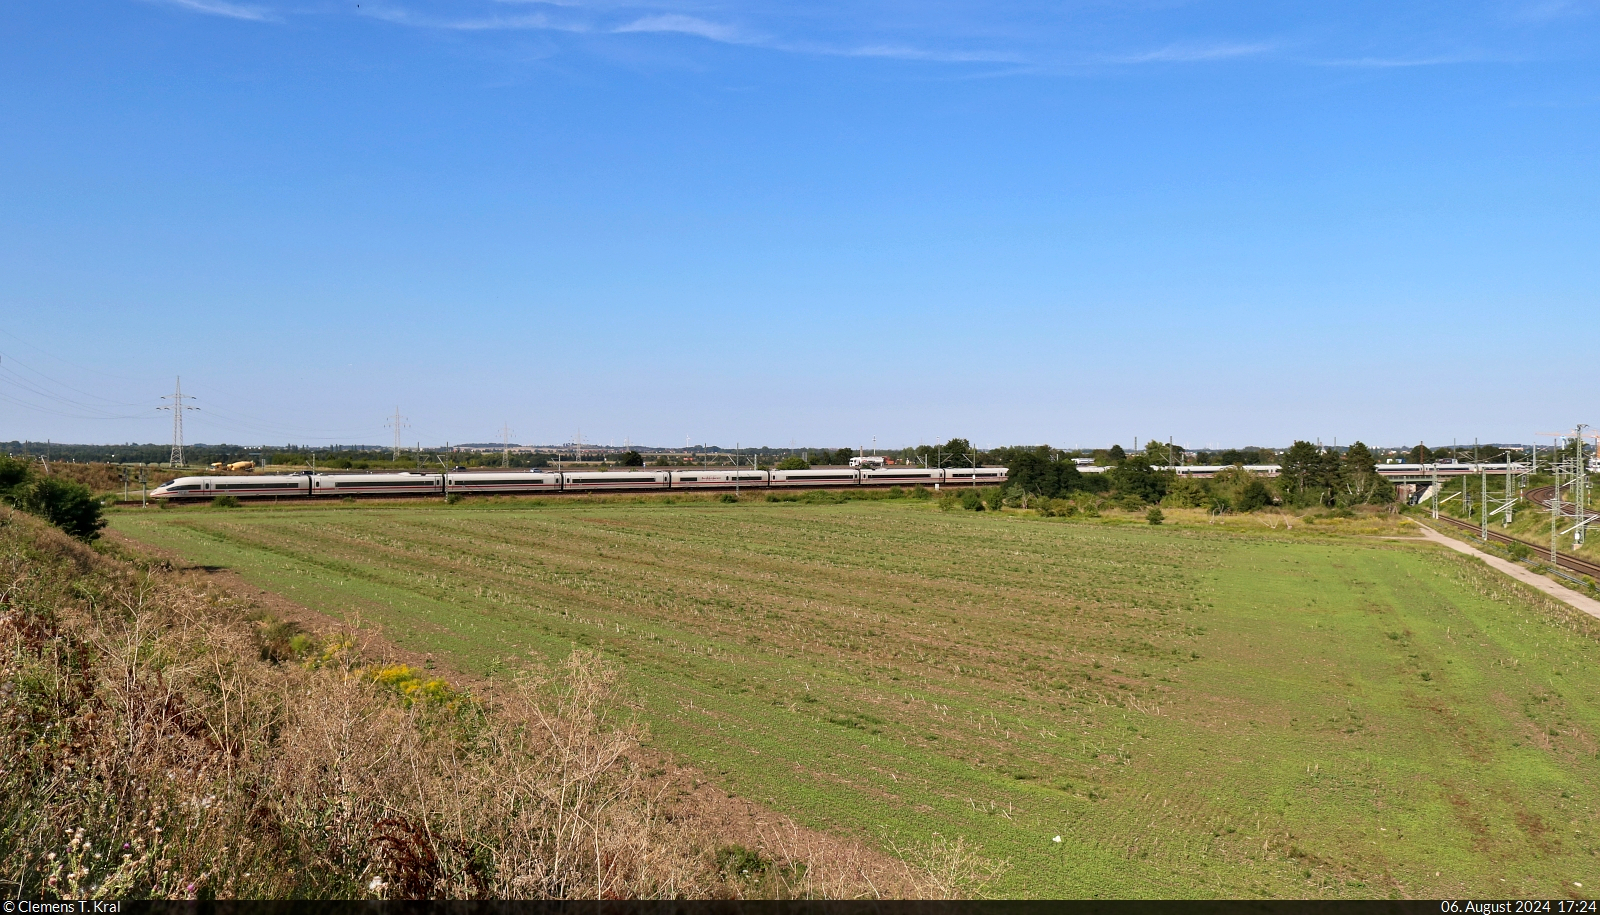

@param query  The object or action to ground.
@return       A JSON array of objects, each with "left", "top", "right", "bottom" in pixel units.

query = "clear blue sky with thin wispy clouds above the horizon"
[{"left": 0, "top": 0, "right": 1600, "bottom": 446}]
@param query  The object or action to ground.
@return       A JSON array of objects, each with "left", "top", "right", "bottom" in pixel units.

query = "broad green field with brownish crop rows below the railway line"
[{"left": 112, "top": 501, "right": 1600, "bottom": 897}]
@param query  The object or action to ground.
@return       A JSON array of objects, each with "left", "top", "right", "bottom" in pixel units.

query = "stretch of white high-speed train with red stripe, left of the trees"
[{"left": 150, "top": 467, "right": 1006, "bottom": 501}]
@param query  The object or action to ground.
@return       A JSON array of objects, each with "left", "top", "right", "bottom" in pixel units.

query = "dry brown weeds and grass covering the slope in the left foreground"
[{"left": 0, "top": 509, "right": 960, "bottom": 899}]
